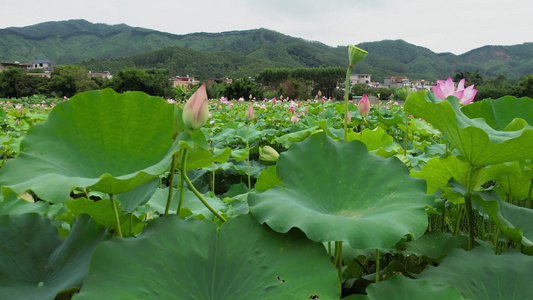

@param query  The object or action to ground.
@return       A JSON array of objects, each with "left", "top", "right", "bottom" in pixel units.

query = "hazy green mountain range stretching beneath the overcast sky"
[{"left": 0, "top": 20, "right": 533, "bottom": 81}]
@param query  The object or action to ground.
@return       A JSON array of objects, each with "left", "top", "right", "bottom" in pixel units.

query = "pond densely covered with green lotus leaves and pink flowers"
[{"left": 0, "top": 89, "right": 533, "bottom": 300}]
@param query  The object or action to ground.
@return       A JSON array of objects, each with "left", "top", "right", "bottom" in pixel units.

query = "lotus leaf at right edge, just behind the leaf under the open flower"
[{"left": 461, "top": 96, "right": 533, "bottom": 130}]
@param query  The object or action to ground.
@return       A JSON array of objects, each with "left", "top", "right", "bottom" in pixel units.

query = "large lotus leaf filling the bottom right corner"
[{"left": 415, "top": 247, "right": 533, "bottom": 300}]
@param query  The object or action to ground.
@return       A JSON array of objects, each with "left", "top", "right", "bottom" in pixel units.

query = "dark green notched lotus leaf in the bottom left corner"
[{"left": 0, "top": 214, "right": 106, "bottom": 299}]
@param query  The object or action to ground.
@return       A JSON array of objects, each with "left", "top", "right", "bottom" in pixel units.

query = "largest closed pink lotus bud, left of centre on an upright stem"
[{"left": 183, "top": 83, "right": 209, "bottom": 130}]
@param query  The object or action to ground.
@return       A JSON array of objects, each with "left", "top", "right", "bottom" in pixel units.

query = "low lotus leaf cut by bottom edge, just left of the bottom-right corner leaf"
[{"left": 348, "top": 275, "right": 465, "bottom": 300}]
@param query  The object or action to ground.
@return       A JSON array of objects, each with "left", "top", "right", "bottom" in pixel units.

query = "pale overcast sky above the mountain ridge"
[{"left": 0, "top": 0, "right": 533, "bottom": 55}]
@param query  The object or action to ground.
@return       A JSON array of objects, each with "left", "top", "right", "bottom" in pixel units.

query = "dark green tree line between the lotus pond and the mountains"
[{"left": 0, "top": 65, "right": 533, "bottom": 100}]
